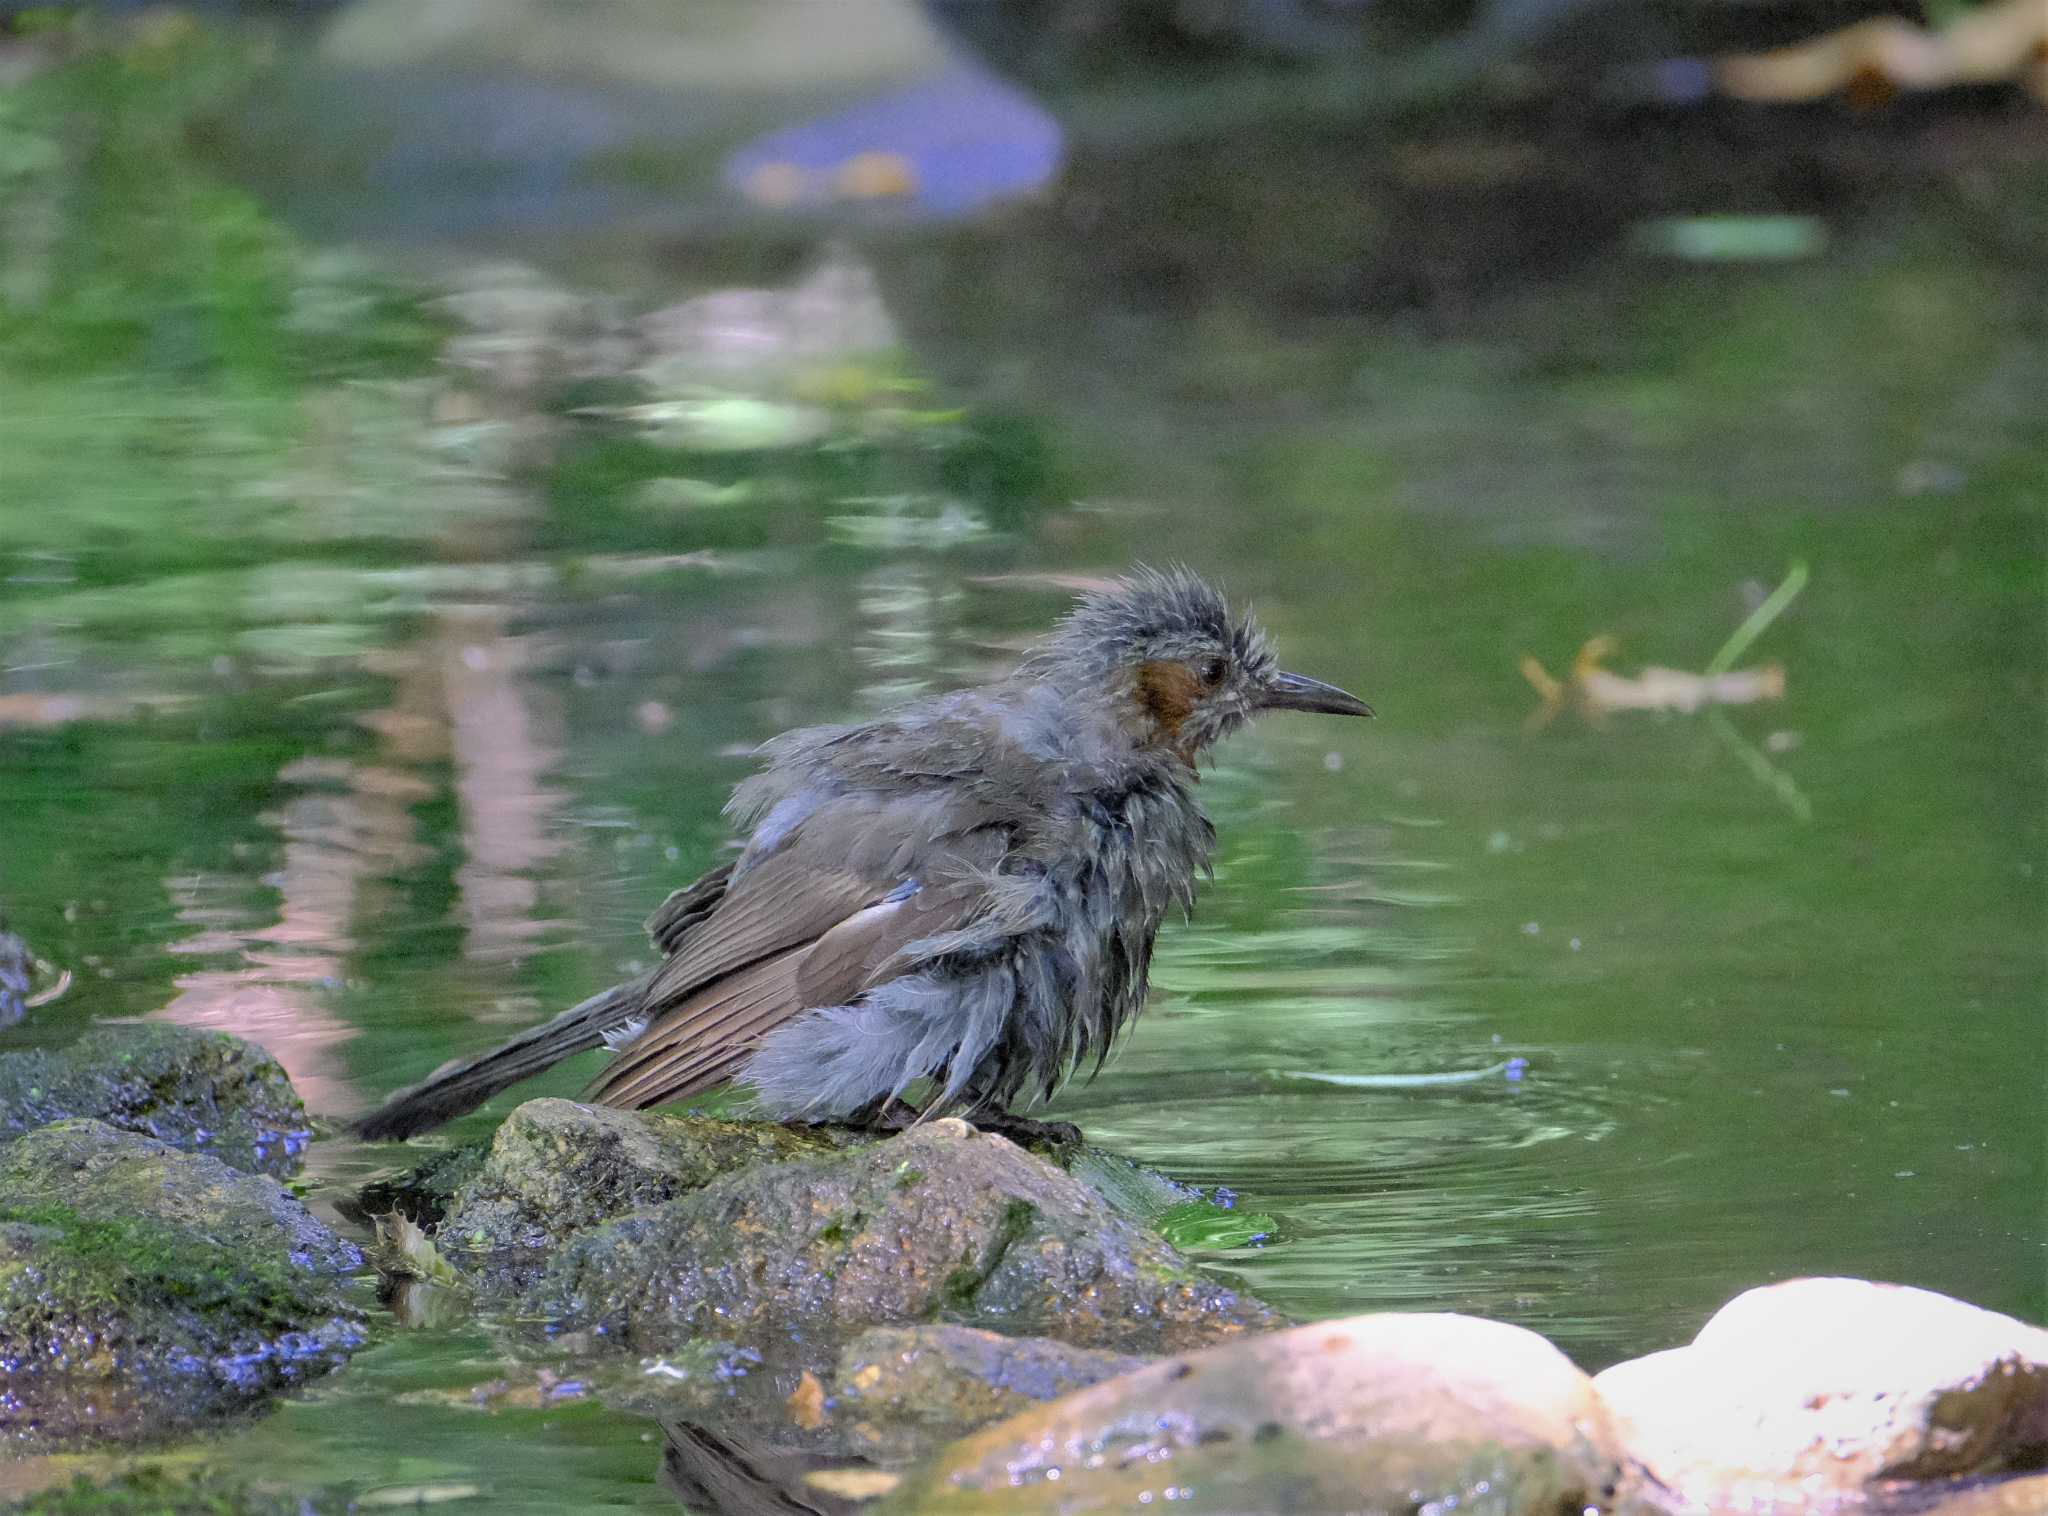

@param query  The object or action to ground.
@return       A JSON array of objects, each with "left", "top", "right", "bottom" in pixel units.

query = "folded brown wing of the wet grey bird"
[{"left": 590, "top": 828, "right": 1008, "bottom": 1108}]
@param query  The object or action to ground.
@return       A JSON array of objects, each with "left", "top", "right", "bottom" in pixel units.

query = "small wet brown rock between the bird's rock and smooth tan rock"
[{"left": 831, "top": 1323, "right": 1149, "bottom": 1455}]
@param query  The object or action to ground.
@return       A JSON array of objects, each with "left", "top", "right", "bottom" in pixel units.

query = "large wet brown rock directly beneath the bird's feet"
[{"left": 520, "top": 1121, "right": 1278, "bottom": 1358}]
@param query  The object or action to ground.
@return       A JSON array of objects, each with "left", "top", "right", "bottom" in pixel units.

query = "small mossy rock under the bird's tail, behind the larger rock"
[{"left": 440, "top": 1100, "right": 838, "bottom": 1252}]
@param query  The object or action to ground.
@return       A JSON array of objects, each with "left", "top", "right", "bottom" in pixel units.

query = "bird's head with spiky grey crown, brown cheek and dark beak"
[{"left": 1026, "top": 570, "right": 1372, "bottom": 762}]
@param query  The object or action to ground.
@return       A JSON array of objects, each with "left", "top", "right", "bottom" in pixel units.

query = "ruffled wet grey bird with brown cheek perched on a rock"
[{"left": 356, "top": 570, "right": 1372, "bottom": 1139}]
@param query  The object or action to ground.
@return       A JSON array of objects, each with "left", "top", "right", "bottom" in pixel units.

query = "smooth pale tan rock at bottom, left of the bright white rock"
[{"left": 887, "top": 1315, "right": 1622, "bottom": 1516}]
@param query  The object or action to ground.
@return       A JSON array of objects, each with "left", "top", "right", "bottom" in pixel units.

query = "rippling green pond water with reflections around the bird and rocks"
[{"left": 0, "top": 17, "right": 2048, "bottom": 1510}]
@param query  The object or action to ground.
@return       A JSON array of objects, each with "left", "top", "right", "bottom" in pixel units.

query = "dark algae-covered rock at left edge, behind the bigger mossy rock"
[{"left": 0, "top": 1024, "right": 311, "bottom": 1176}]
